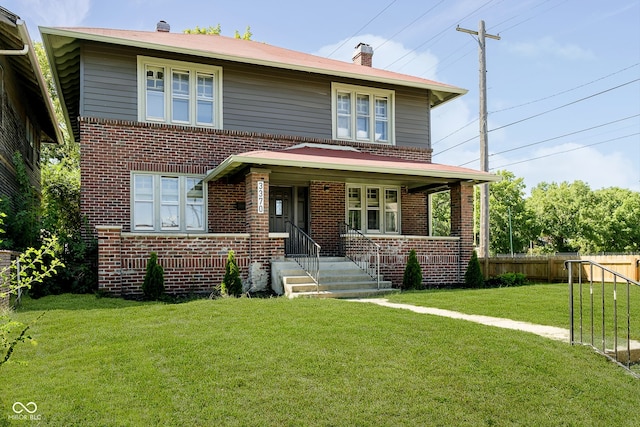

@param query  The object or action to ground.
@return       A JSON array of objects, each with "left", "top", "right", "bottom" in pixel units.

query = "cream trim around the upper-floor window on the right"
[{"left": 331, "top": 82, "right": 396, "bottom": 145}]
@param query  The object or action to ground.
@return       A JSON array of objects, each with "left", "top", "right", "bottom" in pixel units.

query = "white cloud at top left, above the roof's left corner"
[{"left": 23, "top": 0, "right": 91, "bottom": 27}]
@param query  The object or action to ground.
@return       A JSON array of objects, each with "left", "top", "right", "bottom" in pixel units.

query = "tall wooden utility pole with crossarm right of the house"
[{"left": 456, "top": 20, "right": 500, "bottom": 275}]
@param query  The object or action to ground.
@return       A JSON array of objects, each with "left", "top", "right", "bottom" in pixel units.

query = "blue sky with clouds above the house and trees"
[{"left": 6, "top": 0, "right": 640, "bottom": 195}]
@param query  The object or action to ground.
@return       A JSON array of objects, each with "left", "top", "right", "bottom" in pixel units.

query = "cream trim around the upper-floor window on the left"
[{"left": 138, "top": 56, "right": 223, "bottom": 129}]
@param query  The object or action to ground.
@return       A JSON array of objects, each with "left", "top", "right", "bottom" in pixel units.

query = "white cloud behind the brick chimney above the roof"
[{"left": 314, "top": 34, "right": 438, "bottom": 80}]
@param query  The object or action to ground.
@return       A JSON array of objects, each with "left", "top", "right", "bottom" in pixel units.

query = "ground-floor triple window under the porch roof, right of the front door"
[{"left": 347, "top": 185, "right": 400, "bottom": 234}]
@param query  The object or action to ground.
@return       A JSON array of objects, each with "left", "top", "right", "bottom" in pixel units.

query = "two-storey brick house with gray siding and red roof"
[{"left": 40, "top": 21, "right": 496, "bottom": 295}]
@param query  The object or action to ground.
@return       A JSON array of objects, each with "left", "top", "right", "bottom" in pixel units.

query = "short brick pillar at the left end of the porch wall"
[{"left": 96, "top": 225, "right": 122, "bottom": 295}]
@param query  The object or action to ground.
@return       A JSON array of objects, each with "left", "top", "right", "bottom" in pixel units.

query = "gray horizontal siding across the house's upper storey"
[{"left": 80, "top": 44, "right": 429, "bottom": 148}]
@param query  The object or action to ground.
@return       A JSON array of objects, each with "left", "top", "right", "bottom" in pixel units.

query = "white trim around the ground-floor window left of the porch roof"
[{"left": 129, "top": 171, "right": 208, "bottom": 234}]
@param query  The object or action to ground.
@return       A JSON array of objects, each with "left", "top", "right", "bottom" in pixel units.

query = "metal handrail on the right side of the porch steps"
[{"left": 340, "top": 222, "right": 380, "bottom": 289}]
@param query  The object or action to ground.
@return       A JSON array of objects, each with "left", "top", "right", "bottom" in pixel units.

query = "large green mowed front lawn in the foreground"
[{"left": 0, "top": 292, "right": 640, "bottom": 426}]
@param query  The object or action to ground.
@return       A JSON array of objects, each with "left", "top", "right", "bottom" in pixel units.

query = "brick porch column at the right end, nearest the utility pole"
[{"left": 450, "top": 182, "right": 473, "bottom": 283}]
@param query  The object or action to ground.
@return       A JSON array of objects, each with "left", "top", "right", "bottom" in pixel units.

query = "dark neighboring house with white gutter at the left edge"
[{"left": 0, "top": 7, "right": 62, "bottom": 208}]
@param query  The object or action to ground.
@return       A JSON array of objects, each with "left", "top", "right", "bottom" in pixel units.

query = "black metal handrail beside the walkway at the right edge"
[{"left": 564, "top": 260, "right": 640, "bottom": 376}]
